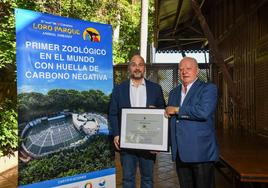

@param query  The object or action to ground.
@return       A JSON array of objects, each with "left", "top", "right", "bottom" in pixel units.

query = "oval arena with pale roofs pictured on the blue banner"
[{"left": 21, "top": 112, "right": 109, "bottom": 159}]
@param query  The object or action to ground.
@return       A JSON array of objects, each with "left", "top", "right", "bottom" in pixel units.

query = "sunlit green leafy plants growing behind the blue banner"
[{"left": 0, "top": 0, "right": 154, "bottom": 157}]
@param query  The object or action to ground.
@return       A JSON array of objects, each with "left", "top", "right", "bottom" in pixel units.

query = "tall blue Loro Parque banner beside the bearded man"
[{"left": 15, "top": 9, "right": 115, "bottom": 188}]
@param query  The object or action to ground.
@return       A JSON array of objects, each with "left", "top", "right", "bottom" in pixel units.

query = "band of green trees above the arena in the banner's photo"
[{"left": 18, "top": 89, "right": 109, "bottom": 123}]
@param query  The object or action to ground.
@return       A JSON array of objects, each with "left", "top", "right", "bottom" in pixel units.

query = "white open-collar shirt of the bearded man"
[{"left": 129, "top": 79, "right": 147, "bottom": 107}]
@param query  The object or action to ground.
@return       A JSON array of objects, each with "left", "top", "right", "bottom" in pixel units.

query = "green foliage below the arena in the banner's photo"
[{"left": 19, "top": 135, "right": 114, "bottom": 185}]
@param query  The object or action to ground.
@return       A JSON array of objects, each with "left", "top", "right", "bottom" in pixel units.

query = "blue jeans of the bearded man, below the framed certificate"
[{"left": 120, "top": 150, "right": 155, "bottom": 188}]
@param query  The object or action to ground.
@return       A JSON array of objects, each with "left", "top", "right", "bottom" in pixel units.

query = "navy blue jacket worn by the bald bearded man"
[{"left": 108, "top": 80, "right": 165, "bottom": 136}]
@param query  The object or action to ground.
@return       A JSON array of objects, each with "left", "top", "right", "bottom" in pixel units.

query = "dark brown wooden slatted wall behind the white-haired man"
[{"left": 209, "top": 0, "right": 268, "bottom": 136}]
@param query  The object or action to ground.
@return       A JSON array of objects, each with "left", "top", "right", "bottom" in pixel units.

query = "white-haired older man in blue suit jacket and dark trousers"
[{"left": 166, "top": 57, "right": 219, "bottom": 188}]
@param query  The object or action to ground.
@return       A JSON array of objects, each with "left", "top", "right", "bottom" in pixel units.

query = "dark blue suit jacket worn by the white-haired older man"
[{"left": 168, "top": 80, "right": 219, "bottom": 162}]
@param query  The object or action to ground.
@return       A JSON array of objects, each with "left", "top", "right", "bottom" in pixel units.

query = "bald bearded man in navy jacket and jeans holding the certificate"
[{"left": 109, "top": 55, "right": 165, "bottom": 188}]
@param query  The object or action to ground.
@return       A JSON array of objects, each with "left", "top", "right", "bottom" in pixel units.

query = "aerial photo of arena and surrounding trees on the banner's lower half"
[{"left": 18, "top": 89, "right": 114, "bottom": 185}]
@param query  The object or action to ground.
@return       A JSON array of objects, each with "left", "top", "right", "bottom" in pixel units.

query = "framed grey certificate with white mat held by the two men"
[{"left": 120, "top": 108, "right": 168, "bottom": 151}]
